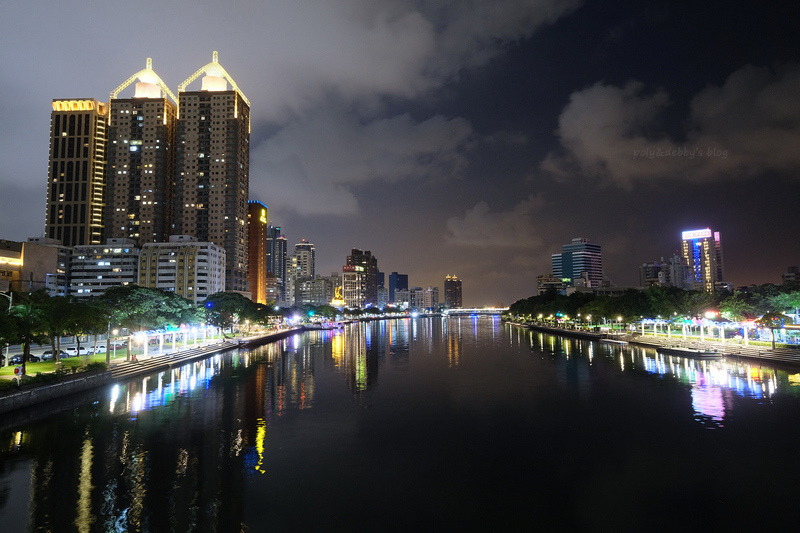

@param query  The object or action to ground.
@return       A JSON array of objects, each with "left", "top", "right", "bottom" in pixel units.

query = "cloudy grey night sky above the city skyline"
[{"left": 0, "top": 0, "right": 800, "bottom": 306}]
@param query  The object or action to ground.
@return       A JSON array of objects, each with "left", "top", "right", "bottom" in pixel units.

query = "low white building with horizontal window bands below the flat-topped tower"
[{"left": 69, "top": 239, "right": 139, "bottom": 299}]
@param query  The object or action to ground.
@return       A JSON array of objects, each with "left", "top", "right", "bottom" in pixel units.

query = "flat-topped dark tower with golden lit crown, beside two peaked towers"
[{"left": 45, "top": 98, "right": 108, "bottom": 246}]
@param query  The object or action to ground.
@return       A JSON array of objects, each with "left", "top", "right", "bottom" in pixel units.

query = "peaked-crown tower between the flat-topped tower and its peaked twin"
[{"left": 103, "top": 58, "right": 178, "bottom": 246}]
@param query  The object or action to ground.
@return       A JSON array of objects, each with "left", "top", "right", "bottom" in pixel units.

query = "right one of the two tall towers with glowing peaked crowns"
[{"left": 173, "top": 52, "right": 250, "bottom": 295}]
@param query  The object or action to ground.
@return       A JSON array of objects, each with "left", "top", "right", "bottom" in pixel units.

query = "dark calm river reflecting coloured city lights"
[{"left": 0, "top": 318, "right": 800, "bottom": 532}]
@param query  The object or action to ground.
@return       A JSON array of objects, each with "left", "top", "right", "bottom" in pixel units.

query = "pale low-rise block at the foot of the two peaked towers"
[{"left": 137, "top": 235, "right": 225, "bottom": 304}]
